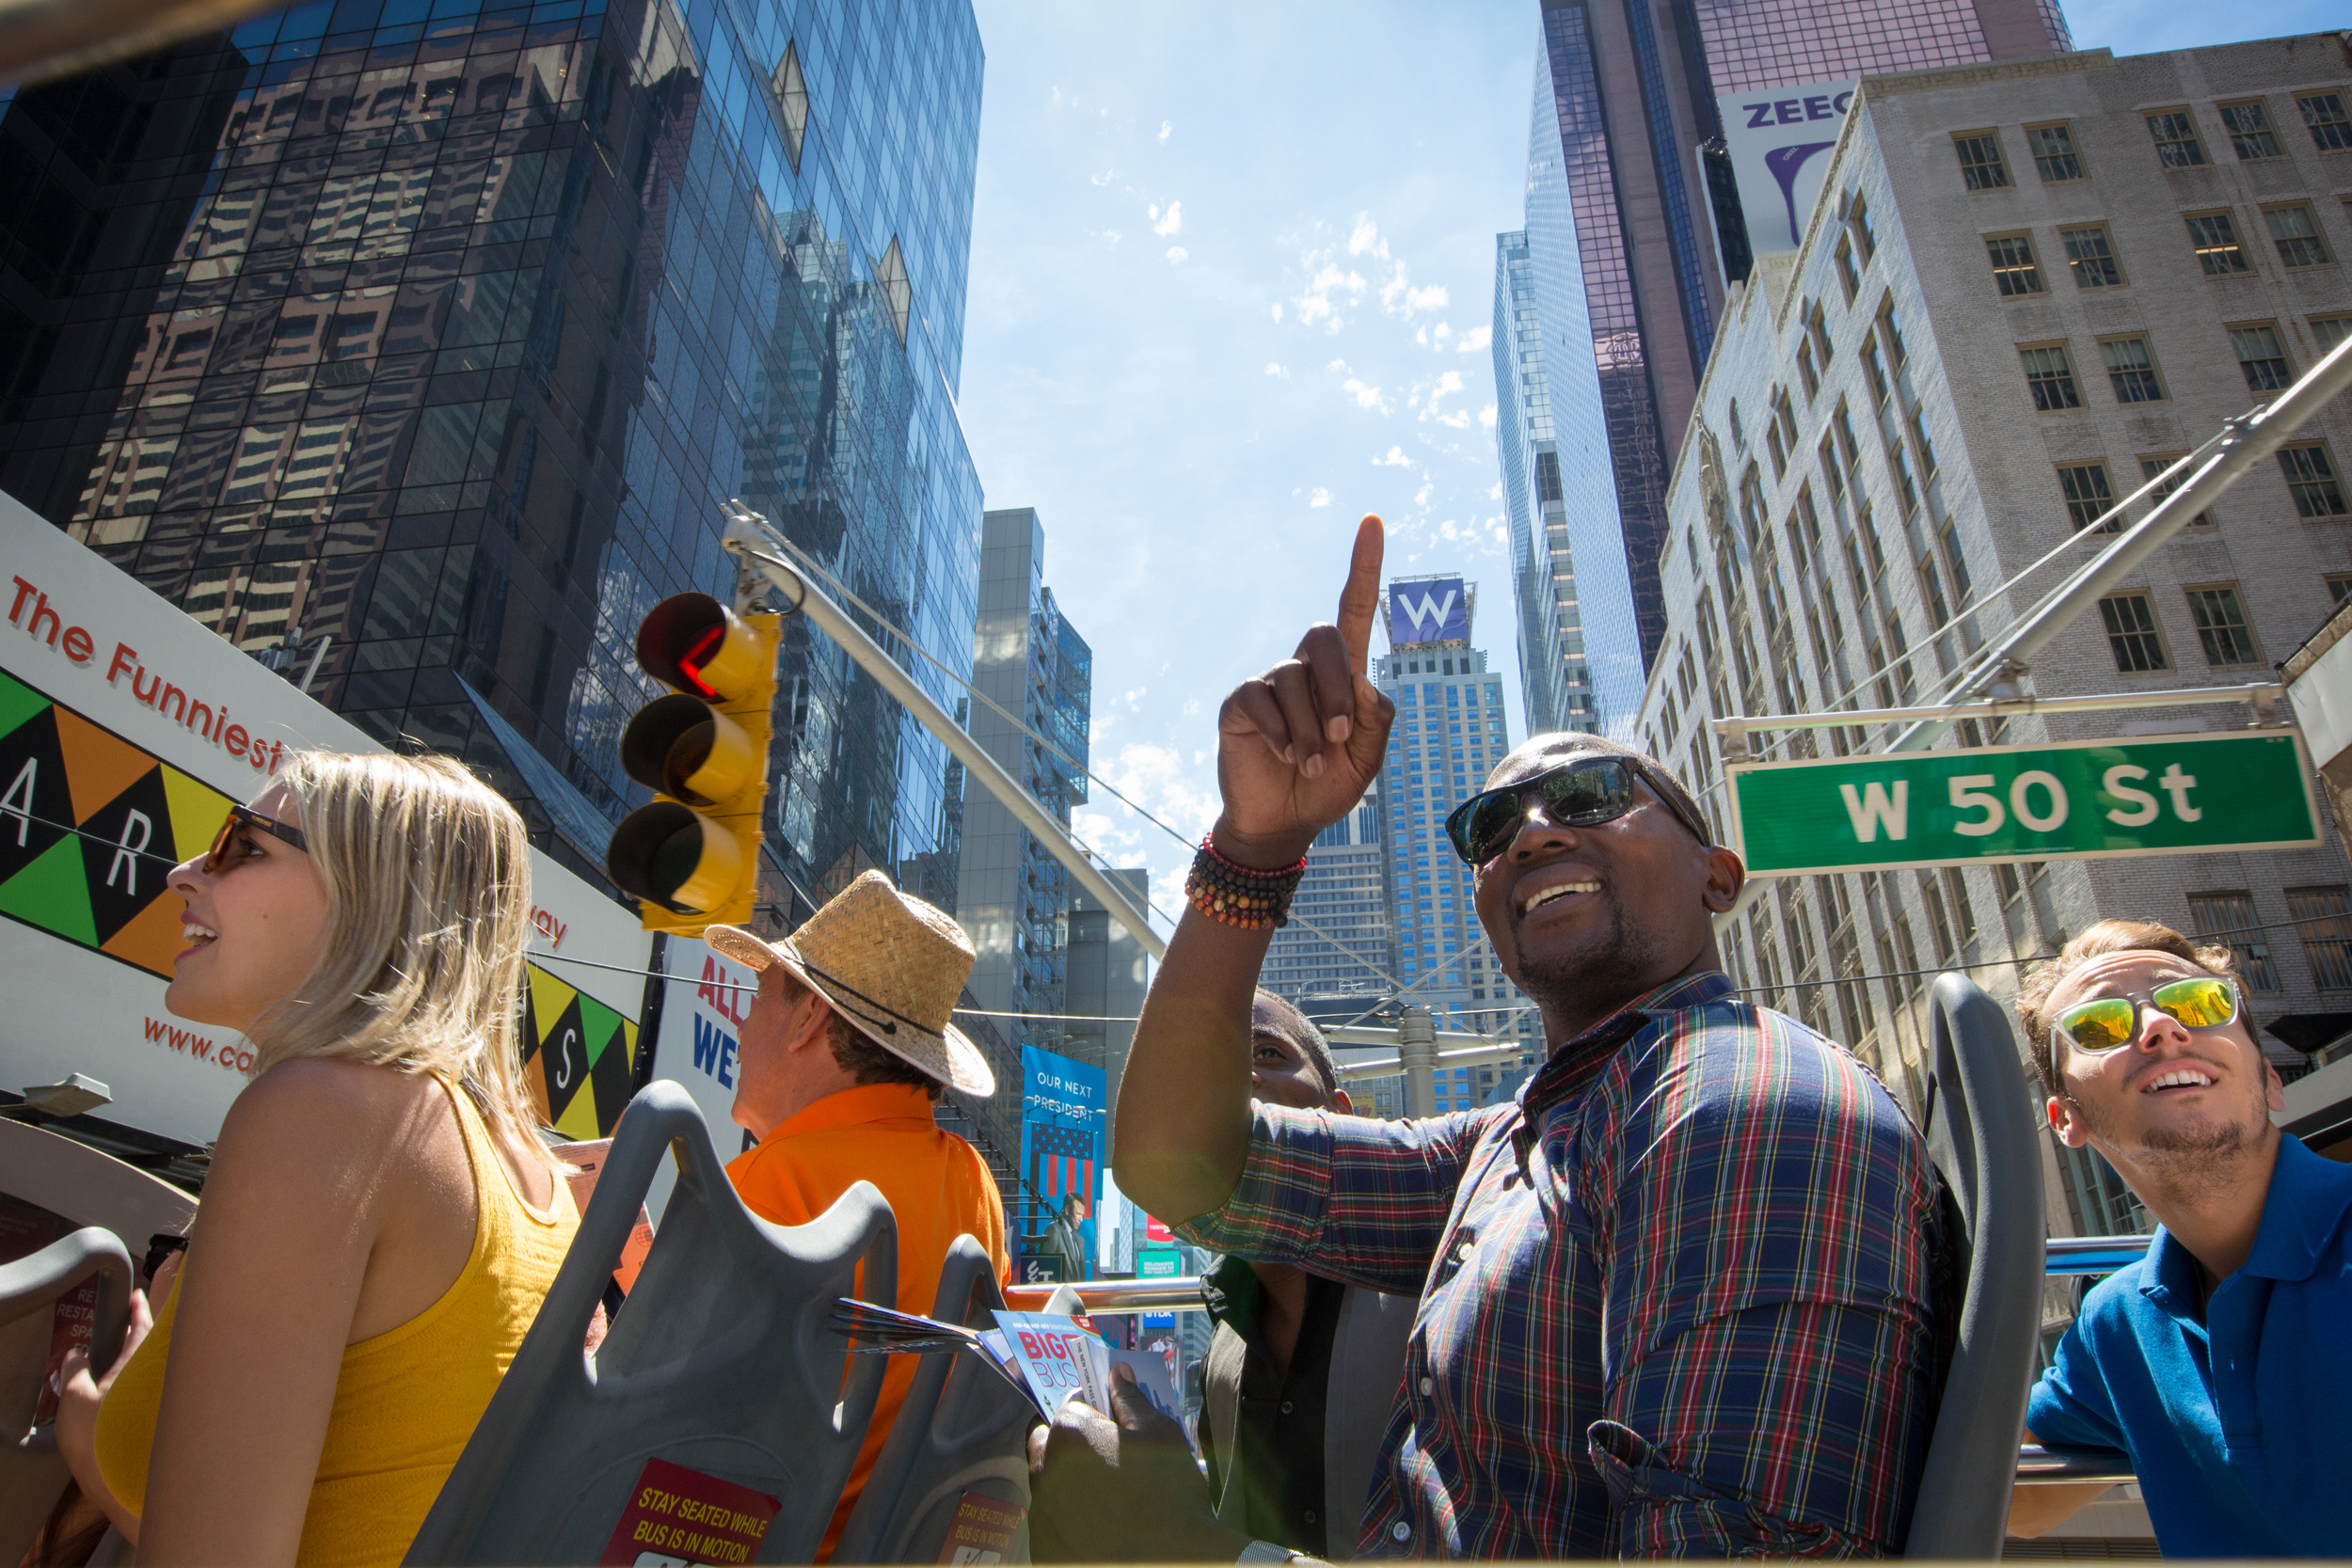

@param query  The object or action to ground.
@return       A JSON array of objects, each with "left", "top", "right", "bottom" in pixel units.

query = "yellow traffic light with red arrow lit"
[{"left": 605, "top": 593, "right": 784, "bottom": 933}]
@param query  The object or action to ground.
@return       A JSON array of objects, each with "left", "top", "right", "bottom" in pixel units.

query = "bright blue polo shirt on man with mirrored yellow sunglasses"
[{"left": 2026, "top": 1133, "right": 2352, "bottom": 1557}]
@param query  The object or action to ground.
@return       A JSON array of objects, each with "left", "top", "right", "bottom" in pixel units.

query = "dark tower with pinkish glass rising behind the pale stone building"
[{"left": 1524, "top": 0, "right": 2073, "bottom": 670}]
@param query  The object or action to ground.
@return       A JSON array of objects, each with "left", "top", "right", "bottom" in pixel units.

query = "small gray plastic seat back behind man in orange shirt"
[{"left": 833, "top": 1237, "right": 1038, "bottom": 1563}]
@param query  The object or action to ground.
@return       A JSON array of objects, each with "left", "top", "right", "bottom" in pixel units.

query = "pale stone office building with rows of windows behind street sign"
[{"left": 1642, "top": 35, "right": 2352, "bottom": 1232}]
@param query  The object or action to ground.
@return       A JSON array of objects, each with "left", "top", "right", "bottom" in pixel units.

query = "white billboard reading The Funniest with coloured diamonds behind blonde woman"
[{"left": 0, "top": 494, "right": 649, "bottom": 1145}]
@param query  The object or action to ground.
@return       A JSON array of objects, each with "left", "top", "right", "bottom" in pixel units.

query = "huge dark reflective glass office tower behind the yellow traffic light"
[{"left": 0, "top": 0, "right": 981, "bottom": 922}]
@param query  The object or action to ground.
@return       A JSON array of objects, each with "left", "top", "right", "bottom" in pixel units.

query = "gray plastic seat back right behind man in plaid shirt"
[{"left": 1905, "top": 974, "right": 2044, "bottom": 1559}]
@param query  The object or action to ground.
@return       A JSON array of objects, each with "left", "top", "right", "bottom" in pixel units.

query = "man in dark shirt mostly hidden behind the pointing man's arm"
[{"left": 1200, "top": 990, "right": 1414, "bottom": 1557}]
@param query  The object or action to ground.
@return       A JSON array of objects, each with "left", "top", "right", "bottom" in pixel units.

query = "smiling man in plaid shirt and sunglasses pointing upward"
[{"left": 1038, "top": 519, "right": 1957, "bottom": 1561}]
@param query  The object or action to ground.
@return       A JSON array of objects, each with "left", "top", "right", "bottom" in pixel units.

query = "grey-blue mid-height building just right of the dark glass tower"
[{"left": 955, "top": 505, "right": 1094, "bottom": 1149}]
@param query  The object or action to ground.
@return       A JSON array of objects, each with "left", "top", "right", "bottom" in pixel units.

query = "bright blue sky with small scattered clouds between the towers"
[{"left": 960, "top": 0, "right": 2343, "bottom": 928}]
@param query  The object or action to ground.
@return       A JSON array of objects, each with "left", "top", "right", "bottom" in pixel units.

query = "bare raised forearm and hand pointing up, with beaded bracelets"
[{"left": 1113, "top": 517, "right": 1395, "bottom": 1220}]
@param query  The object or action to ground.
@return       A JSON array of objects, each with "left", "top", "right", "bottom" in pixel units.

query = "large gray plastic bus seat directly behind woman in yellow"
[{"left": 407, "top": 1082, "right": 898, "bottom": 1563}]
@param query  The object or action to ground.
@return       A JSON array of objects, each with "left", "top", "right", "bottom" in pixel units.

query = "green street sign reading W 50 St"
[{"left": 1726, "top": 729, "right": 2319, "bottom": 877}]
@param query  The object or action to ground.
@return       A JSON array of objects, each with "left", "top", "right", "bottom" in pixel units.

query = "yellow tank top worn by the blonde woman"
[{"left": 97, "top": 1084, "right": 579, "bottom": 1563}]
